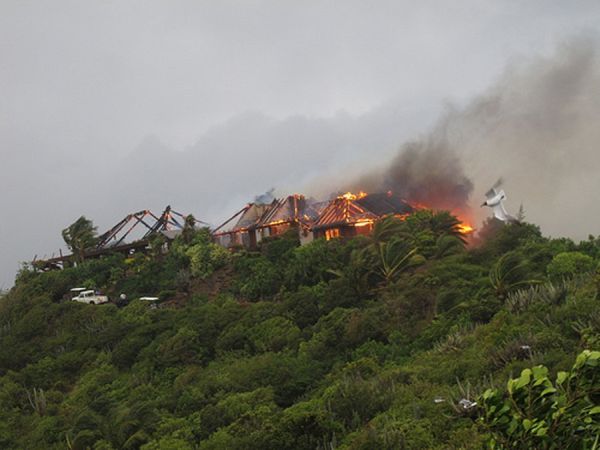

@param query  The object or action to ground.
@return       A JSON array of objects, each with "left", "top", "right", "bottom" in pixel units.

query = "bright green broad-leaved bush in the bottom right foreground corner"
[{"left": 481, "top": 350, "right": 600, "bottom": 449}]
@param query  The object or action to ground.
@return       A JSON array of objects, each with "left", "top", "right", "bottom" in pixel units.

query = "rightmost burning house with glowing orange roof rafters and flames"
[{"left": 312, "top": 192, "right": 413, "bottom": 240}]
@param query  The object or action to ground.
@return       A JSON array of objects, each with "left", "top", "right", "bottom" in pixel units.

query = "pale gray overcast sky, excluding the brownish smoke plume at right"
[{"left": 0, "top": 0, "right": 600, "bottom": 287}]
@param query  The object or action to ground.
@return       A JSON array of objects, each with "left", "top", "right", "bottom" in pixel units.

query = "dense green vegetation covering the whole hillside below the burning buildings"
[{"left": 0, "top": 216, "right": 600, "bottom": 450}]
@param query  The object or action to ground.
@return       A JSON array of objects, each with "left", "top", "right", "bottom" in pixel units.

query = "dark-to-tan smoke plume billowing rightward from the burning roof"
[{"left": 344, "top": 38, "right": 600, "bottom": 238}]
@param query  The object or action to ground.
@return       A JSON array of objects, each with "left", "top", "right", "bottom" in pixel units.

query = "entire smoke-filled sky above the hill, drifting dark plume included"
[{"left": 0, "top": 0, "right": 600, "bottom": 289}]
